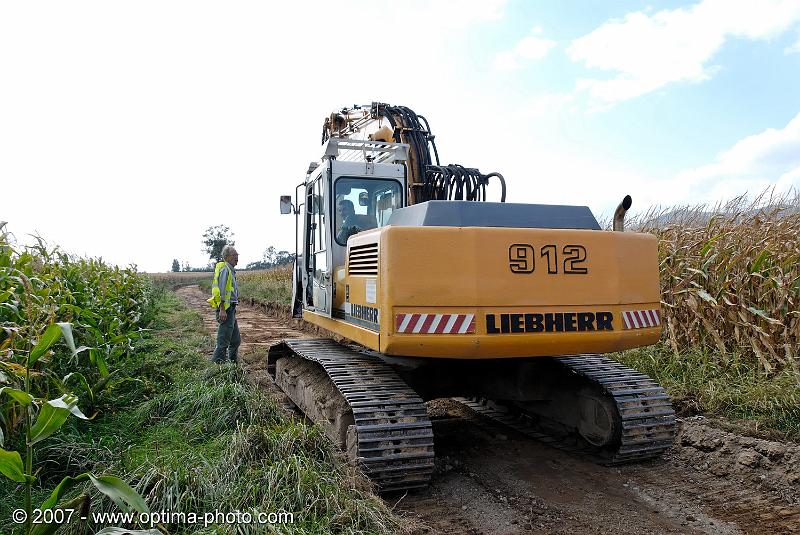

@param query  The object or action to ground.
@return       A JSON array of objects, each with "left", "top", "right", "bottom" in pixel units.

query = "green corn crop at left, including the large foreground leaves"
[{"left": 0, "top": 223, "right": 157, "bottom": 535}]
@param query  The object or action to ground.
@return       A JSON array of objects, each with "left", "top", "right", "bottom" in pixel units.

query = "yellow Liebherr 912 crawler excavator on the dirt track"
[{"left": 268, "top": 103, "right": 675, "bottom": 492}]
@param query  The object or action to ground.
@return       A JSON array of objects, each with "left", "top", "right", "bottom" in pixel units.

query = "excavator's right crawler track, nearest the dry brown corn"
[{"left": 456, "top": 355, "right": 676, "bottom": 465}]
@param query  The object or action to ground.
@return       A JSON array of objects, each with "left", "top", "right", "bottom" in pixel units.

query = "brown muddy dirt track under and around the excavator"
[{"left": 177, "top": 286, "right": 800, "bottom": 535}]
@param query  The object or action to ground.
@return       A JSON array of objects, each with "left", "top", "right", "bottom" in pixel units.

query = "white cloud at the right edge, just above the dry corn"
[{"left": 668, "top": 113, "right": 800, "bottom": 203}]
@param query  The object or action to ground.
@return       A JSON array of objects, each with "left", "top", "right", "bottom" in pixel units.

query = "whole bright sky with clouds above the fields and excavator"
[{"left": 0, "top": 0, "right": 800, "bottom": 272}]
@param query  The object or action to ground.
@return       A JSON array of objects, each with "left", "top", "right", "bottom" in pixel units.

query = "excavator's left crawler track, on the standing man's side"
[{"left": 268, "top": 338, "right": 434, "bottom": 492}]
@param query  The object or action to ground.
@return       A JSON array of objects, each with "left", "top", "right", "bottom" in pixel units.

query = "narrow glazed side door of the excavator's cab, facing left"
[{"left": 306, "top": 169, "right": 333, "bottom": 316}]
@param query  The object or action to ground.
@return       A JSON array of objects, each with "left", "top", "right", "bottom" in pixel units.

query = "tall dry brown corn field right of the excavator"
[{"left": 633, "top": 194, "right": 800, "bottom": 373}]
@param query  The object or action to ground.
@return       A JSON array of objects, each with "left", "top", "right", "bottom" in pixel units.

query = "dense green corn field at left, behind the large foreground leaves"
[{"left": 0, "top": 224, "right": 149, "bottom": 390}]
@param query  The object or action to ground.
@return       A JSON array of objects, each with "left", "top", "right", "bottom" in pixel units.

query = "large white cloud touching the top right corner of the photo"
[{"left": 567, "top": 0, "right": 800, "bottom": 106}]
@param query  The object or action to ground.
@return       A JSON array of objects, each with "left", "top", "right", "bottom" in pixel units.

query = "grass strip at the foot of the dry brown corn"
[{"left": 614, "top": 343, "right": 800, "bottom": 440}]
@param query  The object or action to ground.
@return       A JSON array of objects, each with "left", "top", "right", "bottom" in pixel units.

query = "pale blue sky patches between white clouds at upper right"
[{"left": 465, "top": 2, "right": 800, "bottom": 178}]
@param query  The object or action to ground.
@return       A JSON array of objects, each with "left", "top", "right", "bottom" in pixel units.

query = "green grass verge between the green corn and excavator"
[{"left": 0, "top": 291, "right": 405, "bottom": 534}]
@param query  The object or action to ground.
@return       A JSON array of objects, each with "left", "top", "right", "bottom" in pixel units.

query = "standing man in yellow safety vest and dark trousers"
[{"left": 208, "top": 245, "right": 242, "bottom": 363}]
